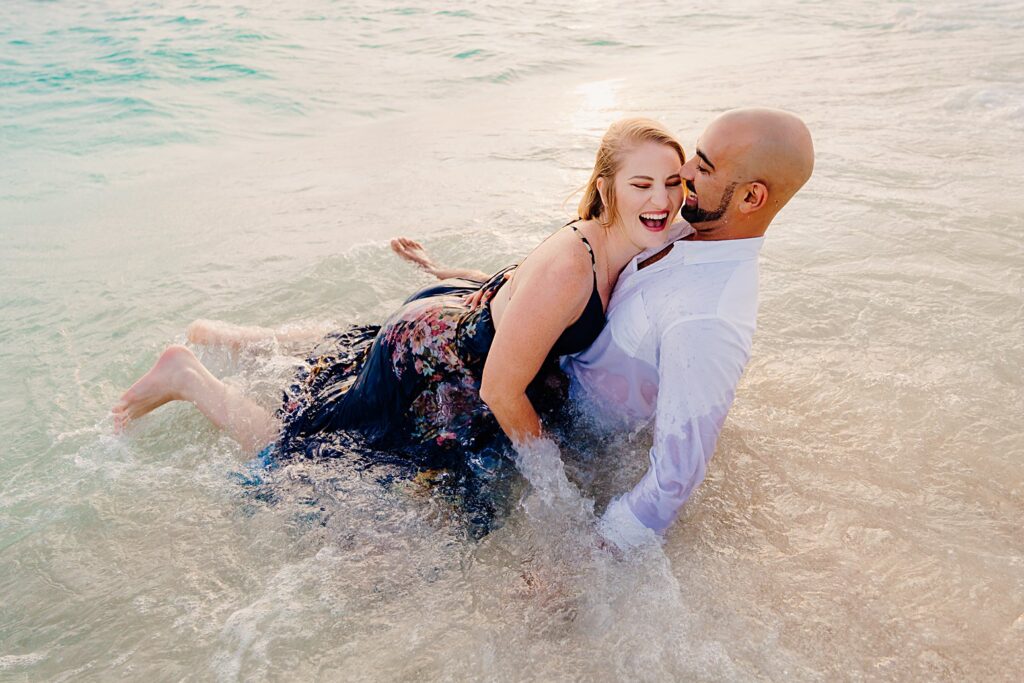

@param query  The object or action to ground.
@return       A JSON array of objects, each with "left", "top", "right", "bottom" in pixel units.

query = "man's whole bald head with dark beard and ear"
[{"left": 680, "top": 109, "right": 814, "bottom": 240}]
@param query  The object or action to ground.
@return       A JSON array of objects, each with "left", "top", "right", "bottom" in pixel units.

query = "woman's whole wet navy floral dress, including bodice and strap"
[{"left": 274, "top": 228, "right": 604, "bottom": 533}]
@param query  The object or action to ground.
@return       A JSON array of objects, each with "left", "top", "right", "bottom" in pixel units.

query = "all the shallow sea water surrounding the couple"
[{"left": 0, "top": 0, "right": 1024, "bottom": 681}]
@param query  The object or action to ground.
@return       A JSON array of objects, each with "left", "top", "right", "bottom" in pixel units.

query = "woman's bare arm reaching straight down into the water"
[{"left": 480, "top": 242, "right": 594, "bottom": 445}]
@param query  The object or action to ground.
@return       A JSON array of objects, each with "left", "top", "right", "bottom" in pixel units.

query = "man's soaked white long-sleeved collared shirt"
[{"left": 562, "top": 232, "right": 764, "bottom": 547}]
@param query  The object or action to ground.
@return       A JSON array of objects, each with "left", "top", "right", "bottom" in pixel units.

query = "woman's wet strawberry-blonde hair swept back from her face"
[{"left": 579, "top": 118, "right": 686, "bottom": 227}]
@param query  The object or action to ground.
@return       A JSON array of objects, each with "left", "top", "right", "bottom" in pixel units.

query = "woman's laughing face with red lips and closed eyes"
[{"left": 598, "top": 142, "right": 686, "bottom": 250}]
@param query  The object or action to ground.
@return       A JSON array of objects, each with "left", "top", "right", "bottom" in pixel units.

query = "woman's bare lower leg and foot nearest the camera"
[{"left": 112, "top": 346, "right": 281, "bottom": 451}]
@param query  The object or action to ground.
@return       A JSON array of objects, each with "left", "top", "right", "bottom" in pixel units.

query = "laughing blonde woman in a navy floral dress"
[{"left": 114, "top": 119, "right": 685, "bottom": 465}]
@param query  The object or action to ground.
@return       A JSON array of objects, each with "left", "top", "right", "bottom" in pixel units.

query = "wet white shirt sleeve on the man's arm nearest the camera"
[{"left": 601, "top": 317, "right": 750, "bottom": 546}]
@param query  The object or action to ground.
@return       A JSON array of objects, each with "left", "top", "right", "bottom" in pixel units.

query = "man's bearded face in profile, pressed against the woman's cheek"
[{"left": 679, "top": 124, "right": 739, "bottom": 227}]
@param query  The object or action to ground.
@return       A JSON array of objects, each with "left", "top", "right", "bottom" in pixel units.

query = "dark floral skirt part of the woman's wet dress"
[{"left": 280, "top": 266, "right": 557, "bottom": 467}]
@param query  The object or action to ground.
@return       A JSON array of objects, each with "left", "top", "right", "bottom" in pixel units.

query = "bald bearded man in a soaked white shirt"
[{"left": 392, "top": 109, "right": 814, "bottom": 548}]
